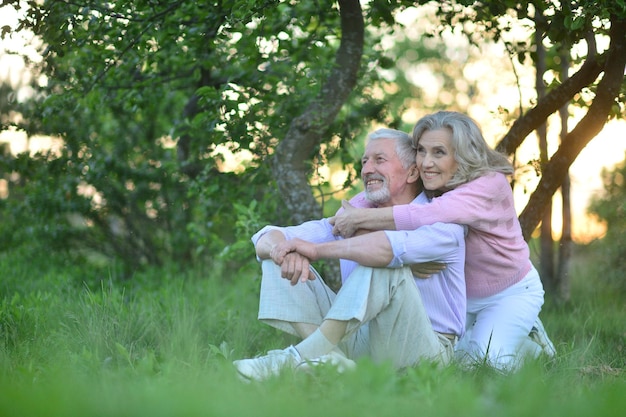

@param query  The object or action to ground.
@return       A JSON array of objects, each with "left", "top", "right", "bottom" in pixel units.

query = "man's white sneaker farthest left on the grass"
[{"left": 233, "top": 346, "right": 302, "bottom": 381}]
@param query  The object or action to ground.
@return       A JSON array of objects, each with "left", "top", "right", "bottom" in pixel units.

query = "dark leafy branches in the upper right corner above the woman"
[{"left": 422, "top": 0, "right": 626, "bottom": 118}]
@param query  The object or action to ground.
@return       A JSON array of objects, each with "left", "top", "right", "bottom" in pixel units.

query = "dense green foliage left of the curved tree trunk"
[{"left": 2, "top": 0, "right": 404, "bottom": 269}]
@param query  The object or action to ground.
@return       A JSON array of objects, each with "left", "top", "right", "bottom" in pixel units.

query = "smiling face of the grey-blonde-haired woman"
[{"left": 416, "top": 129, "right": 458, "bottom": 190}]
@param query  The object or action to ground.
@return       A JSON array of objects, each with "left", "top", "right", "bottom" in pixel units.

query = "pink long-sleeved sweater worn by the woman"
[{"left": 354, "top": 173, "right": 532, "bottom": 298}]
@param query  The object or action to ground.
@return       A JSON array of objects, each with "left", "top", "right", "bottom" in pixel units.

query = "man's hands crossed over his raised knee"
[{"left": 270, "top": 239, "right": 317, "bottom": 285}]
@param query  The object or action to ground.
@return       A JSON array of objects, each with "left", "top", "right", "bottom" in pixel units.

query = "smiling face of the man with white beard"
[{"left": 361, "top": 139, "right": 415, "bottom": 207}]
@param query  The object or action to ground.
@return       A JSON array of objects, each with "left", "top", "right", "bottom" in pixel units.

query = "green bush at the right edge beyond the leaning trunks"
[{"left": 589, "top": 154, "right": 626, "bottom": 292}]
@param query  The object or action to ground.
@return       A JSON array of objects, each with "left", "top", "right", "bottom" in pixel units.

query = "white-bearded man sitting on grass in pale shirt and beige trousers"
[{"left": 234, "top": 129, "right": 466, "bottom": 380}]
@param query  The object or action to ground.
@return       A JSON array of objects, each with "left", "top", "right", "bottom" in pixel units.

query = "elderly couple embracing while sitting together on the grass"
[{"left": 234, "top": 112, "right": 555, "bottom": 380}]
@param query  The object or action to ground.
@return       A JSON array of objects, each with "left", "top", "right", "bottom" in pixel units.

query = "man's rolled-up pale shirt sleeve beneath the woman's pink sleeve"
[{"left": 385, "top": 223, "right": 466, "bottom": 268}]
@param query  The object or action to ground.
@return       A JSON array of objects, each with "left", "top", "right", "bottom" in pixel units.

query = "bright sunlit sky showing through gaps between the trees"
[{"left": 0, "top": 7, "right": 626, "bottom": 242}]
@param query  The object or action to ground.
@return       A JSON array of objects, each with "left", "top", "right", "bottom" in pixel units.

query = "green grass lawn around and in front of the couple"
[{"left": 0, "top": 244, "right": 626, "bottom": 417}]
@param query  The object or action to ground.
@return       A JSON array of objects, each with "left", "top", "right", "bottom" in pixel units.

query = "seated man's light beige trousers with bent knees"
[{"left": 259, "top": 260, "right": 453, "bottom": 368}]
